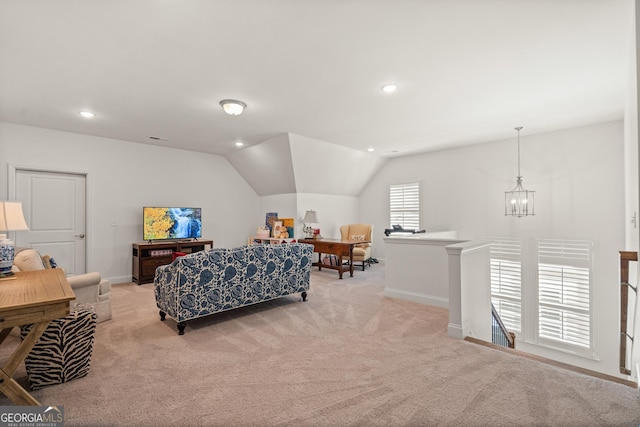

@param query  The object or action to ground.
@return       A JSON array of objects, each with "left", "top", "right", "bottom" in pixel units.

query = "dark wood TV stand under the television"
[{"left": 131, "top": 240, "right": 213, "bottom": 285}]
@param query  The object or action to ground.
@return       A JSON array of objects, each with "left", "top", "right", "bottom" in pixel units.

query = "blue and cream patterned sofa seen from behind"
[{"left": 154, "top": 243, "right": 313, "bottom": 335}]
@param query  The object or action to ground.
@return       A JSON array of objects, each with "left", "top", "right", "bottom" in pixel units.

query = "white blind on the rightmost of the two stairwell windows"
[{"left": 538, "top": 240, "right": 592, "bottom": 348}]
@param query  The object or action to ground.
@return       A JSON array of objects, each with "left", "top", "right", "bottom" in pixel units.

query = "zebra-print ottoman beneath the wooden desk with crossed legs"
[{"left": 20, "top": 307, "right": 97, "bottom": 390}]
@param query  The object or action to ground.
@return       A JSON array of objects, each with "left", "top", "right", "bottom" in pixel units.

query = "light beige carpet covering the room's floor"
[{"left": 0, "top": 264, "right": 640, "bottom": 427}]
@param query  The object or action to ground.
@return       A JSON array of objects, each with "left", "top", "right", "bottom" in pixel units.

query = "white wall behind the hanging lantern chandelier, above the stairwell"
[{"left": 359, "top": 121, "right": 625, "bottom": 375}]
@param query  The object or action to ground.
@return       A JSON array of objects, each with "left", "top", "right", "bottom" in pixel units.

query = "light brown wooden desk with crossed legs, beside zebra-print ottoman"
[{"left": 0, "top": 268, "right": 76, "bottom": 405}]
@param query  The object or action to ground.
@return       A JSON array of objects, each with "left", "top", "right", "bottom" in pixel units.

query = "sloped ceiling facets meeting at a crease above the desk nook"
[{"left": 226, "top": 133, "right": 388, "bottom": 196}]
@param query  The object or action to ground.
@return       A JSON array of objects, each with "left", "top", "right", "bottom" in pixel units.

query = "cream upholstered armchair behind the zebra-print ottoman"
[{"left": 11, "top": 248, "right": 111, "bottom": 322}]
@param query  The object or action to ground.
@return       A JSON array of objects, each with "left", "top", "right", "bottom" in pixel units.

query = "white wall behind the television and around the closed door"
[{"left": 0, "top": 123, "right": 259, "bottom": 283}]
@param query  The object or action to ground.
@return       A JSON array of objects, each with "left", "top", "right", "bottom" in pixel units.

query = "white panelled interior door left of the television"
[{"left": 14, "top": 169, "right": 86, "bottom": 275}]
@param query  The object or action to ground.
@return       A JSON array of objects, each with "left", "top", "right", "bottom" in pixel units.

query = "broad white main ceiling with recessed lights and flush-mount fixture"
[{"left": 0, "top": 0, "right": 633, "bottom": 161}]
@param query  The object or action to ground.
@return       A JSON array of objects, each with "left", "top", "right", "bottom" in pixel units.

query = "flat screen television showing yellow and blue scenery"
[{"left": 142, "top": 207, "right": 202, "bottom": 241}]
